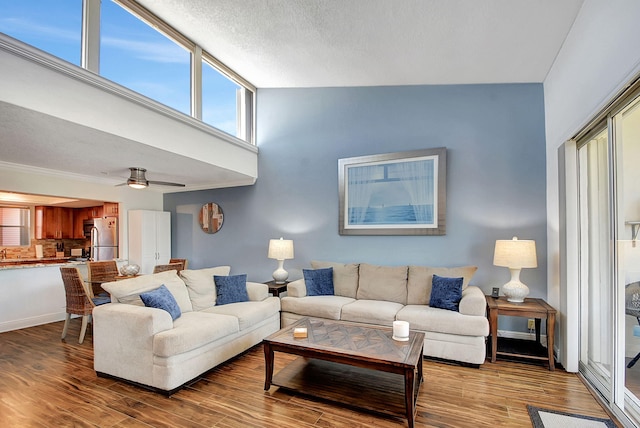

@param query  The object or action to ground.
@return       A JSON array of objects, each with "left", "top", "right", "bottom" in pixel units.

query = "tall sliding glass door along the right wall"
[{"left": 578, "top": 93, "right": 640, "bottom": 425}]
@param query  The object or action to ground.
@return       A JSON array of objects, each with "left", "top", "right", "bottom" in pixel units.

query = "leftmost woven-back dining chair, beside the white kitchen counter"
[{"left": 60, "top": 267, "right": 111, "bottom": 343}]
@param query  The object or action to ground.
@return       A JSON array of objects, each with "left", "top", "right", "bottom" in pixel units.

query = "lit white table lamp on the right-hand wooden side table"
[{"left": 493, "top": 237, "right": 538, "bottom": 303}]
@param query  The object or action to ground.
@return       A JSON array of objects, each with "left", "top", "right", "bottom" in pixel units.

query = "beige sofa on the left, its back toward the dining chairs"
[{"left": 93, "top": 266, "right": 280, "bottom": 394}]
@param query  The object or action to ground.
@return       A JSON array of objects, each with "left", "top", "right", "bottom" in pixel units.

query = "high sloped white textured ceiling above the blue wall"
[{"left": 138, "top": 0, "right": 583, "bottom": 88}]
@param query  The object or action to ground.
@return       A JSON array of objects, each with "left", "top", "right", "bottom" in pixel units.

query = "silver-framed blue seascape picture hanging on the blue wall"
[{"left": 338, "top": 147, "right": 447, "bottom": 235}]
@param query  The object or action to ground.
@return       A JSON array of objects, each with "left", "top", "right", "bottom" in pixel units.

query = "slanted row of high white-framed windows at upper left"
[{"left": 0, "top": 0, "right": 255, "bottom": 144}]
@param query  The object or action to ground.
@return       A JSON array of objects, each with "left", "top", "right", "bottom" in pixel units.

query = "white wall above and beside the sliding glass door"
[{"left": 544, "top": 0, "right": 640, "bottom": 371}]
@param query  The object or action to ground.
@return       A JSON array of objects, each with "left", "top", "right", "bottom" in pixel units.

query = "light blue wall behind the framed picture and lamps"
[{"left": 164, "top": 84, "right": 546, "bottom": 310}]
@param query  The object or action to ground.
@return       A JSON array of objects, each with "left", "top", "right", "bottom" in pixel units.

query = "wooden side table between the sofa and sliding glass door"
[{"left": 485, "top": 296, "right": 556, "bottom": 371}]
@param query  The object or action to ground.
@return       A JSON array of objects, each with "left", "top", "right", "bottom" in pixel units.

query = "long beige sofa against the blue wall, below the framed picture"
[{"left": 281, "top": 261, "right": 489, "bottom": 365}]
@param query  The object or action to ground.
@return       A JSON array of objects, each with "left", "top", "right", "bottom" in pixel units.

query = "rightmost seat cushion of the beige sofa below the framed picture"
[{"left": 396, "top": 305, "right": 489, "bottom": 336}]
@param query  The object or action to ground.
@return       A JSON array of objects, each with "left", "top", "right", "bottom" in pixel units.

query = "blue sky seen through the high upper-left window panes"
[{"left": 0, "top": 0, "right": 240, "bottom": 135}]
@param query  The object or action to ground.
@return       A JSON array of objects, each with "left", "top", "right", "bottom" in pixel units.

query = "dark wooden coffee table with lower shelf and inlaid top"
[{"left": 263, "top": 318, "right": 424, "bottom": 427}]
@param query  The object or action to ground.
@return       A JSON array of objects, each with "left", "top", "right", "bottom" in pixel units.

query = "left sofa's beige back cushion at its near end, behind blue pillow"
[{"left": 102, "top": 270, "right": 193, "bottom": 313}]
